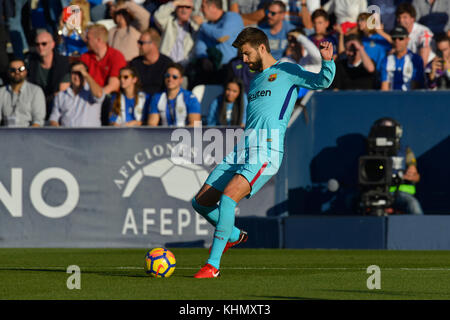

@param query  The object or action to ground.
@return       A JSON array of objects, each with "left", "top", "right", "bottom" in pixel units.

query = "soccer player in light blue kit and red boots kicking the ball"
[{"left": 192, "top": 27, "right": 336, "bottom": 278}]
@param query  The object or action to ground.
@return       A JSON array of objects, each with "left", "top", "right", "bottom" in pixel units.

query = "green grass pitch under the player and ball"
[{"left": 0, "top": 248, "right": 450, "bottom": 300}]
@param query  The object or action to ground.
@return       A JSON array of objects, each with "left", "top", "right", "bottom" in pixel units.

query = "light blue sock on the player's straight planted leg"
[{"left": 208, "top": 194, "right": 236, "bottom": 269}]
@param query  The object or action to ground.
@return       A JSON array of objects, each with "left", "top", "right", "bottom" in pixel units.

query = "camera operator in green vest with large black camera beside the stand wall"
[{"left": 359, "top": 117, "right": 423, "bottom": 215}]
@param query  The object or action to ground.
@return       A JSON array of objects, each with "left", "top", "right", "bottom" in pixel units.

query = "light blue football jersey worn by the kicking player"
[{"left": 243, "top": 60, "right": 336, "bottom": 152}]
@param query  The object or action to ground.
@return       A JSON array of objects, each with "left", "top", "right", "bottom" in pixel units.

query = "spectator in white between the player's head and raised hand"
[{"left": 281, "top": 28, "right": 322, "bottom": 73}]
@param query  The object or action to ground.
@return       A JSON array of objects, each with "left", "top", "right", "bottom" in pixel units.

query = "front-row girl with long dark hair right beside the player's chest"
[{"left": 207, "top": 78, "right": 248, "bottom": 127}]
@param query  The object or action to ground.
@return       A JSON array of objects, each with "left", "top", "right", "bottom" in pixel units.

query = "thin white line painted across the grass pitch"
[{"left": 0, "top": 266, "right": 450, "bottom": 271}]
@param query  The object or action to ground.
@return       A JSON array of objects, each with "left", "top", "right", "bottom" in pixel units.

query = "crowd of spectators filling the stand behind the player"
[{"left": 0, "top": 0, "right": 450, "bottom": 127}]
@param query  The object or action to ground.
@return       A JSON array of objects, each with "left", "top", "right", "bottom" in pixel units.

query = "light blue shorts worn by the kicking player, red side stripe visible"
[{"left": 205, "top": 148, "right": 283, "bottom": 198}]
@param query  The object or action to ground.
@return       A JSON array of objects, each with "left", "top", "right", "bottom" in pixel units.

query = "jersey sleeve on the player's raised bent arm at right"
[{"left": 282, "top": 60, "right": 336, "bottom": 90}]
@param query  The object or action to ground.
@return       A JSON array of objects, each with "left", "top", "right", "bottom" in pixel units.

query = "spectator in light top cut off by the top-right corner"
[{"left": 412, "top": 0, "right": 450, "bottom": 34}]
